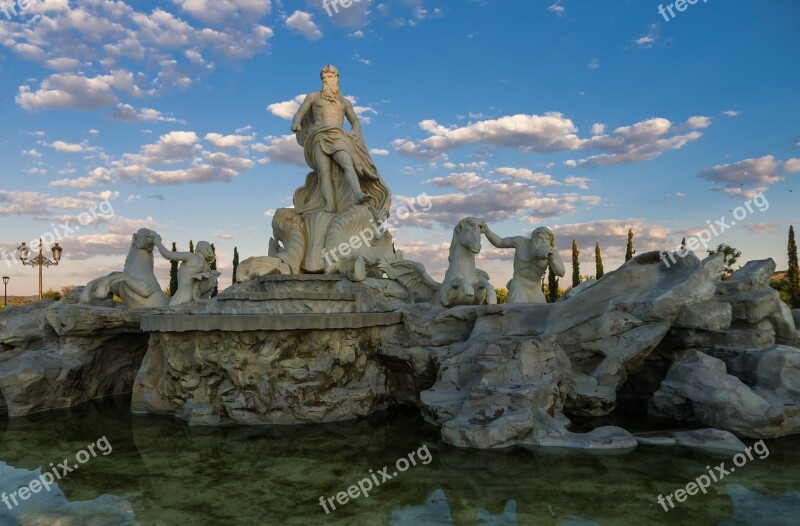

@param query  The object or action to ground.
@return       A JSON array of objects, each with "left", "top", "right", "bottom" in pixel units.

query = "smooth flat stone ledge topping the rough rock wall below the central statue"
[{"left": 141, "top": 312, "right": 403, "bottom": 332}]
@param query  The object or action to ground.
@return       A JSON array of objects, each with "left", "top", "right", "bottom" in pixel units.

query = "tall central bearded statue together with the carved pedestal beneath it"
[{"left": 262, "top": 65, "right": 394, "bottom": 280}]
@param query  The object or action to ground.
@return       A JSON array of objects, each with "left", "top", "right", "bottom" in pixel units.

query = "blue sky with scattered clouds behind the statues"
[{"left": 0, "top": 0, "right": 800, "bottom": 295}]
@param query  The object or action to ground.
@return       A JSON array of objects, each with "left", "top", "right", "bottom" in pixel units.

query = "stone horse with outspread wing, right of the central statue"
[{"left": 381, "top": 217, "right": 497, "bottom": 307}]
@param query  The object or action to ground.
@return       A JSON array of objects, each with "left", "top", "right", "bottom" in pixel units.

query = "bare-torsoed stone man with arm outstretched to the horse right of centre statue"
[{"left": 481, "top": 222, "right": 566, "bottom": 303}]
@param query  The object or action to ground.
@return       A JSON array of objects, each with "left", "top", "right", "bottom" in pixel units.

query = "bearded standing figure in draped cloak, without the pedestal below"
[{"left": 292, "top": 65, "right": 388, "bottom": 213}]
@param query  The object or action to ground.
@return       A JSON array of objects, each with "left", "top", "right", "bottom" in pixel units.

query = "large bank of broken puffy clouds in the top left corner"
[{"left": 0, "top": 0, "right": 273, "bottom": 111}]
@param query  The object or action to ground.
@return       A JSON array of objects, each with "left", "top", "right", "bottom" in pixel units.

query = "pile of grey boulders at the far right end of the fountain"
[{"left": 650, "top": 259, "right": 800, "bottom": 438}]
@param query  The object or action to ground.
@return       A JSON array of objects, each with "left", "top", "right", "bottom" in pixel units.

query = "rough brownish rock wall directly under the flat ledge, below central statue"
[{"left": 132, "top": 328, "right": 387, "bottom": 425}]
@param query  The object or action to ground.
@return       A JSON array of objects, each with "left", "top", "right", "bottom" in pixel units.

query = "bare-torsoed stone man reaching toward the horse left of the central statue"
[{"left": 155, "top": 235, "right": 221, "bottom": 306}]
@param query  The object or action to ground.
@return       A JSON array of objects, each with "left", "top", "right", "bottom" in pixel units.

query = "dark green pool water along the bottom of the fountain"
[{"left": 0, "top": 400, "right": 800, "bottom": 526}]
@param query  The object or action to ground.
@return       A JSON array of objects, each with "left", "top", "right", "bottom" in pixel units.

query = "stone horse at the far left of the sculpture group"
[{"left": 80, "top": 228, "right": 169, "bottom": 309}]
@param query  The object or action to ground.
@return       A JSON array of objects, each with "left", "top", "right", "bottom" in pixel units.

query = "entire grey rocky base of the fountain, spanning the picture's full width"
[{"left": 0, "top": 252, "right": 800, "bottom": 451}]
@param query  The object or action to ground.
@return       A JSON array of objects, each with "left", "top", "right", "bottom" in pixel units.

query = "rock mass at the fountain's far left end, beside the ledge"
[{"left": 0, "top": 295, "right": 148, "bottom": 416}]
